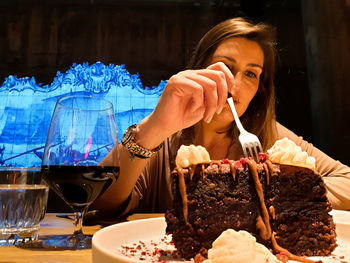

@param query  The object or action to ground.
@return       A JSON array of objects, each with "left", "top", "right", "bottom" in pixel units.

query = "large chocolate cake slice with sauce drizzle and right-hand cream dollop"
[{"left": 165, "top": 139, "right": 336, "bottom": 259}]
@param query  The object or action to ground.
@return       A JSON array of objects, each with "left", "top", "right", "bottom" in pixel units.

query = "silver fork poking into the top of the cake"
[{"left": 227, "top": 97, "right": 262, "bottom": 161}]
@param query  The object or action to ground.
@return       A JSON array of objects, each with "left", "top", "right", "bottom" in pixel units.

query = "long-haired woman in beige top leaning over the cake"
[{"left": 94, "top": 18, "right": 350, "bottom": 215}]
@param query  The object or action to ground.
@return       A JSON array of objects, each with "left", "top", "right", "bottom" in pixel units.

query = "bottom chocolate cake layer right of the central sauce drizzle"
[{"left": 271, "top": 201, "right": 336, "bottom": 256}]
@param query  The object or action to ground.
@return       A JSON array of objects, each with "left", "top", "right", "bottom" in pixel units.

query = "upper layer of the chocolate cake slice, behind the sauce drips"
[{"left": 173, "top": 164, "right": 327, "bottom": 204}]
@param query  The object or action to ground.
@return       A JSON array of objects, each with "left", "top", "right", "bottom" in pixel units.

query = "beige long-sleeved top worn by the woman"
[{"left": 122, "top": 123, "right": 350, "bottom": 215}]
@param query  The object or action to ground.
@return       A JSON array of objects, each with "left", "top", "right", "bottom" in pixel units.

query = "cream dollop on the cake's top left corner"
[{"left": 175, "top": 144, "right": 210, "bottom": 168}]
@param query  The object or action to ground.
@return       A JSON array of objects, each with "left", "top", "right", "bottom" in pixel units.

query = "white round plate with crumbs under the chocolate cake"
[{"left": 92, "top": 210, "right": 350, "bottom": 263}]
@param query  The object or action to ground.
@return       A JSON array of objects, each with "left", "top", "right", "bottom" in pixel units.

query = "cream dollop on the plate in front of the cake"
[{"left": 203, "top": 229, "right": 280, "bottom": 263}]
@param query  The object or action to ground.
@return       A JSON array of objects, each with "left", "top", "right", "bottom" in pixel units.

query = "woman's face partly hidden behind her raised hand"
[{"left": 209, "top": 37, "right": 264, "bottom": 127}]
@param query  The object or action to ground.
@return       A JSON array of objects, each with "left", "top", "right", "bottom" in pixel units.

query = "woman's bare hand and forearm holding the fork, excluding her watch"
[{"left": 94, "top": 62, "right": 234, "bottom": 213}]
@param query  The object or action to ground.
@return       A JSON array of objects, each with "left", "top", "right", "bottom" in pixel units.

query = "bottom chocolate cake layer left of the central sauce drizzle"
[{"left": 166, "top": 202, "right": 259, "bottom": 258}]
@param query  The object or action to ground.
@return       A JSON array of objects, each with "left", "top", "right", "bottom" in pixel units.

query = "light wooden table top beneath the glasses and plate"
[{"left": 0, "top": 213, "right": 162, "bottom": 263}]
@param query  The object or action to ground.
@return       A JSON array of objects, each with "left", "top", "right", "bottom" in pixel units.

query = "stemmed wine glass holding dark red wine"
[{"left": 42, "top": 95, "right": 119, "bottom": 249}]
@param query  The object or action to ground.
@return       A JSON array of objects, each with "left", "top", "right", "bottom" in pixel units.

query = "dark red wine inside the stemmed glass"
[{"left": 42, "top": 165, "right": 119, "bottom": 206}]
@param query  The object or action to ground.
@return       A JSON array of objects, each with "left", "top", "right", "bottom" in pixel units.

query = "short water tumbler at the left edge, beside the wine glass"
[{"left": 0, "top": 167, "right": 49, "bottom": 246}]
